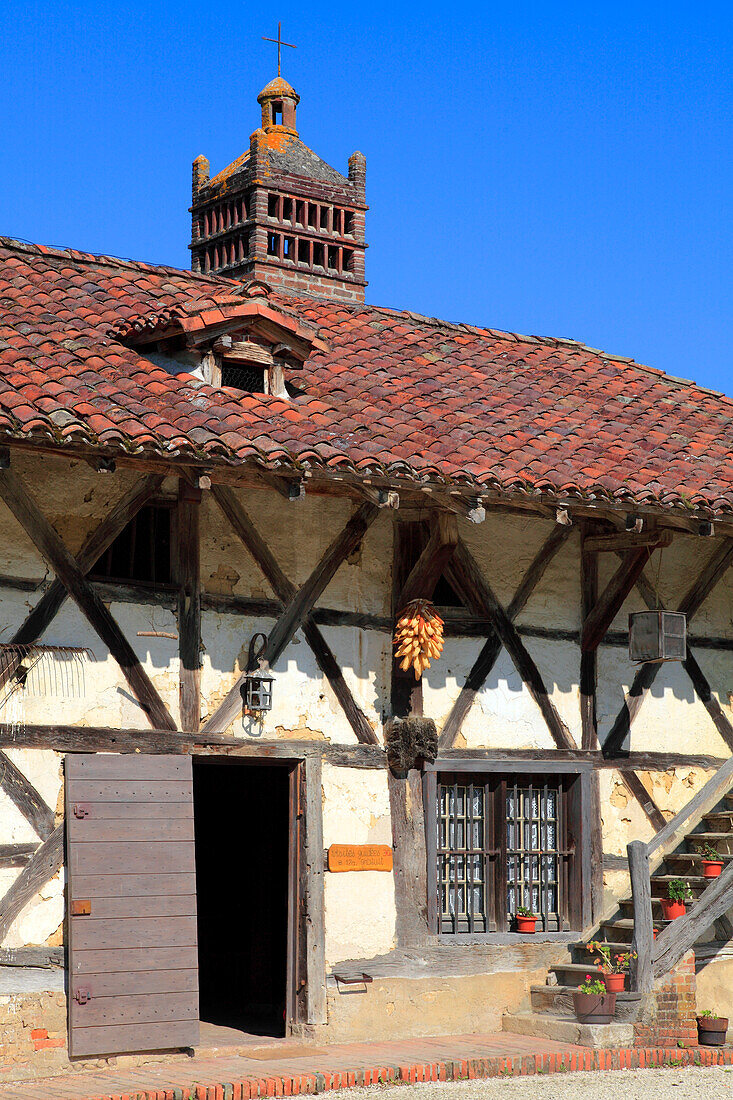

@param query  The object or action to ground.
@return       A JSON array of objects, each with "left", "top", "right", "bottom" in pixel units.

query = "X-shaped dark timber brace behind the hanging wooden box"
[{"left": 603, "top": 539, "right": 733, "bottom": 757}]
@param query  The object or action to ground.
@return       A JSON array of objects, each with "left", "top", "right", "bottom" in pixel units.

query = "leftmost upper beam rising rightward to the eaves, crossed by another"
[{"left": 0, "top": 474, "right": 164, "bottom": 686}]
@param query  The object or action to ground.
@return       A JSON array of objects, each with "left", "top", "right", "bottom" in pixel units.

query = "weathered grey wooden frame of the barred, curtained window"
[{"left": 423, "top": 757, "right": 601, "bottom": 944}]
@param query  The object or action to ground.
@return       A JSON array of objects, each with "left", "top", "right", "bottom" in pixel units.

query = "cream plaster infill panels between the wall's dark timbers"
[{"left": 0, "top": 453, "right": 733, "bottom": 1051}]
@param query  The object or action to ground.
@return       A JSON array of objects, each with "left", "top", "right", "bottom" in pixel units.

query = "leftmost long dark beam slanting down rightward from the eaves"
[{"left": 0, "top": 470, "right": 176, "bottom": 729}]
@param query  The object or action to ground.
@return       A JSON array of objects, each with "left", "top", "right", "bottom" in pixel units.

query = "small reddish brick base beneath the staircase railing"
[{"left": 634, "top": 952, "right": 698, "bottom": 1047}]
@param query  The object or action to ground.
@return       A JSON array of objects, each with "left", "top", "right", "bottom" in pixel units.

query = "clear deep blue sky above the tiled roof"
[{"left": 0, "top": 0, "right": 733, "bottom": 394}]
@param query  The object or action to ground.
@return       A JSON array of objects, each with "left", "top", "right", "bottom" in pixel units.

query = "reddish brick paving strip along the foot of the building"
[{"left": 2, "top": 1032, "right": 733, "bottom": 1100}]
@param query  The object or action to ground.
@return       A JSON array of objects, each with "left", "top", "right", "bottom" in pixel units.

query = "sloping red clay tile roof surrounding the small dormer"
[{"left": 0, "top": 238, "right": 733, "bottom": 515}]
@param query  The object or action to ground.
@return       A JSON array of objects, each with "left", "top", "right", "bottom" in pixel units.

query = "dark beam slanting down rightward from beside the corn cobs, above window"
[{"left": 447, "top": 541, "right": 577, "bottom": 748}]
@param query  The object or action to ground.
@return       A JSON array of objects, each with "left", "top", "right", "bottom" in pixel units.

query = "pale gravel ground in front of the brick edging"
[{"left": 338, "top": 1066, "right": 733, "bottom": 1100}]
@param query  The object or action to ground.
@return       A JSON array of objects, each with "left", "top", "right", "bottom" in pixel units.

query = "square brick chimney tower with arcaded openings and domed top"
[{"left": 190, "top": 77, "right": 368, "bottom": 301}]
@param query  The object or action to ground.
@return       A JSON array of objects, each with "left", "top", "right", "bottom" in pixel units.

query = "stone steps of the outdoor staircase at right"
[{"left": 503, "top": 792, "right": 733, "bottom": 1046}]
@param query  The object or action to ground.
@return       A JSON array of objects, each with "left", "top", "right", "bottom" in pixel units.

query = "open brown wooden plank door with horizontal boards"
[{"left": 66, "top": 754, "right": 198, "bottom": 1058}]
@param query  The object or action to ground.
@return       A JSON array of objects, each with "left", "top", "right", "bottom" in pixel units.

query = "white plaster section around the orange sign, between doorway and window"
[{"left": 322, "top": 765, "right": 395, "bottom": 966}]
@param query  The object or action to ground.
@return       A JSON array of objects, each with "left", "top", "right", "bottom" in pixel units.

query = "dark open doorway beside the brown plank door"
[{"left": 194, "top": 757, "right": 291, "bottom": 1035}]
